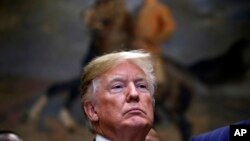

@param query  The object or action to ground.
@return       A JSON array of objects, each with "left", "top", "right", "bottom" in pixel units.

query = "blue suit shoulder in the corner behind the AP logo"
[{"left": 190, "top": 119, "right": 250, "bottom": 141}]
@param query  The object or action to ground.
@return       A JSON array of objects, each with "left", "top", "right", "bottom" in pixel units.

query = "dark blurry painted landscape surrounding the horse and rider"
[{"left": 0, "top": 0, "right": 250, "bottom": 140}]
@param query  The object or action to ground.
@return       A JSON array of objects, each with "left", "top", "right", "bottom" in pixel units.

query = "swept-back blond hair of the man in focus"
[{"left": 81, "top": 50, "right": 155, "bottom": 102}]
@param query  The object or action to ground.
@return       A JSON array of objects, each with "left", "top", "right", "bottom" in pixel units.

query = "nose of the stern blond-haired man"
[{"left": 127, "top": 82, "right": 140, "bottom": 102}]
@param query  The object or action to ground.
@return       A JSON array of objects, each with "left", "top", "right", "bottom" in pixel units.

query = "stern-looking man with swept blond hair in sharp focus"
[{"left": 81, "top": 51, "right": 155, "bottom": 141}]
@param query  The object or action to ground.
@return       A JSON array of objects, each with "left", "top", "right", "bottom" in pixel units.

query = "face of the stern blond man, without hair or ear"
[{"left": 94, "top": 62, "right": 153, "bottom": 130}]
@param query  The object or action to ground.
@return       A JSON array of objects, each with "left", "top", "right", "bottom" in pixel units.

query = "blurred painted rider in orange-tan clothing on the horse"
[{"left": 133, "top": 0, "right": 176, "bottom": 85}]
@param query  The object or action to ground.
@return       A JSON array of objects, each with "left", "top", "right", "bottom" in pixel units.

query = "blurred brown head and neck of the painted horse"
[{"left": 84, "top": 0, "right": 132, "bottom": 55}]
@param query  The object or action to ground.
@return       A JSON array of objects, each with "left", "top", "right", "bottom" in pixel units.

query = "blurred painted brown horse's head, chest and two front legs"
[{"left": 23, "top": 0, "right": 131, "bottom": 131}]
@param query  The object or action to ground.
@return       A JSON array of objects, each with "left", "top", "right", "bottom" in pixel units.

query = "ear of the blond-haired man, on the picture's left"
[{"left": 83, "top": 102, "right": 99, "bottom": 122}]
